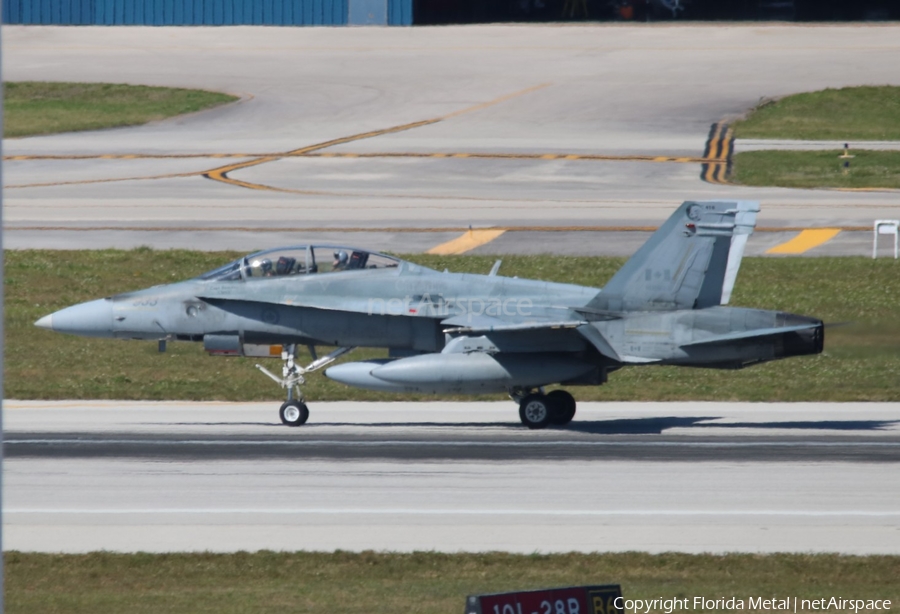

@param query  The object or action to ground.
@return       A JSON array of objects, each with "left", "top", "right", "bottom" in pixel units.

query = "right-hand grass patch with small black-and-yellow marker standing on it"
[{"left": 731, "top": 150, "right": 900, "bottom": 189}]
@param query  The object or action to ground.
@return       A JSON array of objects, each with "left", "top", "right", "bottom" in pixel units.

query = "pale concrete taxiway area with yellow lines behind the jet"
[{"left": 3, "top": 24, "right": 900, "bottom": 254}]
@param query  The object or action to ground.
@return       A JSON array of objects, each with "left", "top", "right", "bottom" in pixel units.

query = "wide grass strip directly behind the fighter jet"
[{"left": 4, "top": 248, "right": 900, "bottom": 402}]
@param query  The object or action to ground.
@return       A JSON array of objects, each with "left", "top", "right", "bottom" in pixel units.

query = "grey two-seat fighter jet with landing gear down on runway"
[{"left": 36, "top": 201, "right": 824, "bottom": 429}]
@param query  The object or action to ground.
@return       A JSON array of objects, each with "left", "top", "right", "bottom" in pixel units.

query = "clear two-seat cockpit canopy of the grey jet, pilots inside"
[{"left": 198, "top": 245, "right": 401, "bottom": 281}]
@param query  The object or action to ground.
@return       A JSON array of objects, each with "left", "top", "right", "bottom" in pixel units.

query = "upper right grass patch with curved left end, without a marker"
[{"left": 734, "top": 85, "right": 900, "bottom": 145}]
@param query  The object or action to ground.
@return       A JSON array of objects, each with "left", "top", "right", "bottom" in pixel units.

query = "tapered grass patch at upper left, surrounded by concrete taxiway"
[{"left": 3, "top": 81, "right": 237, "bottom": 138}]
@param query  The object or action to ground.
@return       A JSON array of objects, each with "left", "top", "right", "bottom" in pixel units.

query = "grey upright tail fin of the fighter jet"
[{"left": 590, "top": 201, "right": 759, "bottom": 311}]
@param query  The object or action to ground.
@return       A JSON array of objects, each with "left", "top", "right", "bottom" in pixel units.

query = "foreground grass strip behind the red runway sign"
[{"left": 6, "top": 552, "right": 900, "bottom": 614}]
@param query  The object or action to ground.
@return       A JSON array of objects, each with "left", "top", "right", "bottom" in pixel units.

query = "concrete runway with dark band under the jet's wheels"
[{"left": 4, "top": 401, "right": 900, "bottom": 554}]
